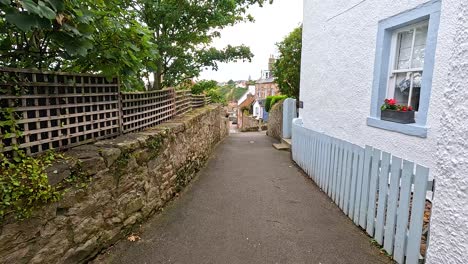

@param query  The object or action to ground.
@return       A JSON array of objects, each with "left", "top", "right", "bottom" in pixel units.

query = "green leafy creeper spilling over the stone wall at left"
[{"left": 0, "top": 146, "right": 91, "bottom": 223}]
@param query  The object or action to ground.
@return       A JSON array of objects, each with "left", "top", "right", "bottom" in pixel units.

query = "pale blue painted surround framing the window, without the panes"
[{"left": 367, "top": 0, "right": 441, "bottom": 138}]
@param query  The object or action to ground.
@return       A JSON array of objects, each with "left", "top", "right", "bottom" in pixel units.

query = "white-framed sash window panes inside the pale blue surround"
[{"left": 386, "top": 20, "right": 428, "bottom": 111}]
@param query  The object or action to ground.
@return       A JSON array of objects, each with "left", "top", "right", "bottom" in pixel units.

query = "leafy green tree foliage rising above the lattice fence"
[{"left": 0, "top": 0, "right": 271, "bottom": 89}]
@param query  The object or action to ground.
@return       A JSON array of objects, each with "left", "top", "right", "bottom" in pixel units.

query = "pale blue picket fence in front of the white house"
[{"left": 292, "top": 119, "right": 433, "bottom": 264}]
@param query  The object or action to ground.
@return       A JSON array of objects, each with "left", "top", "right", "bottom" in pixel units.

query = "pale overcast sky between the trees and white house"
[{"left": 199, "top": 0, "right": 303, "bottom": 81}]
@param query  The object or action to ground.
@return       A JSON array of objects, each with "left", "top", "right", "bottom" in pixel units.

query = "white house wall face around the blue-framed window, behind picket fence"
[{"left": 300, "top": 0, "right": 462, "bottom": 172}]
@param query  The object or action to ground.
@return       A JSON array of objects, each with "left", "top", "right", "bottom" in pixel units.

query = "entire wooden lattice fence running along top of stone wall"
[{"left": 0, "top": 68, "right": 208, "bottom": 154}]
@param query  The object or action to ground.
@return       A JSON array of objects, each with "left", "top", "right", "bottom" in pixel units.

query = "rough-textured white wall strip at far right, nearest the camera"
[{"left": 426, "top": 1, "right": 468, "bottom": 264}]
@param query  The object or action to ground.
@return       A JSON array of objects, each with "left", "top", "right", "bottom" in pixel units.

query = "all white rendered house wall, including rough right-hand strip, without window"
[{"left": 300, "top": 0, "right": 468, "bottom": 263}]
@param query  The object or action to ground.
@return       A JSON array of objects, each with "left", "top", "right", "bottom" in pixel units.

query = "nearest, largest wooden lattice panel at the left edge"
[{"left": 0, "top": 68, "right": 120, "bottom": 154}]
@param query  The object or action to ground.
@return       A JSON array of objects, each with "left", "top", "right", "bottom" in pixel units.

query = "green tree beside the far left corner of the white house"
[{"left": 273, "top": 26, "right": 302, "bottom": 98}]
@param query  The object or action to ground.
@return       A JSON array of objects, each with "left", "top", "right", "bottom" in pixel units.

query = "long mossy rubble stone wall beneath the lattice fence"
[{"left": 0, "top": 105, "right": 229, "bottom": 263}]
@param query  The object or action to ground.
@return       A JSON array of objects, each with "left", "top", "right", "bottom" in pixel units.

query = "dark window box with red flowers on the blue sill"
[{"left": 380, "top": 99, "right": 415, "bottom": 124}]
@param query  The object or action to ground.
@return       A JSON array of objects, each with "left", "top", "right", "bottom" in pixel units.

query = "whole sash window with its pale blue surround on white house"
[{"left": 367, "top": 0, "right": 441, "bottom": 138}]
